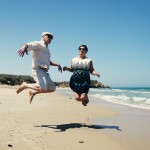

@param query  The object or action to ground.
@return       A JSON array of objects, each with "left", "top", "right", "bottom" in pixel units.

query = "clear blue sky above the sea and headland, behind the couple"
[{"left": 0, "top": 0, "right": 150, "bottom": 87}]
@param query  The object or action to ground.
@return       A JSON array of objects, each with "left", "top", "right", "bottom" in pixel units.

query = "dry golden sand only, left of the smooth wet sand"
[{"left": 0, "top": 86, "right": 149, "bottom": 150}]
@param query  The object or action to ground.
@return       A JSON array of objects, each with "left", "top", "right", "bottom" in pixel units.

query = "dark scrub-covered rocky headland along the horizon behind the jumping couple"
[{"left": 0, "top": 74, "right": 109, "bottom": 88}]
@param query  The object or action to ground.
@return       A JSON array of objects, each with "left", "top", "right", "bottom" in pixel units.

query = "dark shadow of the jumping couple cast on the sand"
[{"left": 34, "top": 123, "right": 121, "bottom": 132}]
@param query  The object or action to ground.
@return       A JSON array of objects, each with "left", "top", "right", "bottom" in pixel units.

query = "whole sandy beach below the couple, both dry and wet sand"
[{"left": 0, "top": 86, "right": 150, "bottom": 150}]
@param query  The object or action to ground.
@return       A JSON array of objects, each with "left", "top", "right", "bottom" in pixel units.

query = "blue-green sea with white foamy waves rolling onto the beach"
[{"left": 56, "top": 88, "right": 150, "bottom": 109}]
